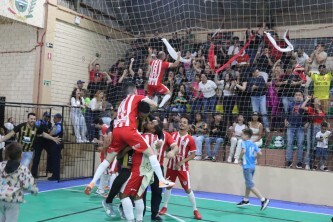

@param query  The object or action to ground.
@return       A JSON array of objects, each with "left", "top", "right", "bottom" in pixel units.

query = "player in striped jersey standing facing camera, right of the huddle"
[{"left": 159, "top": 117, "right": 202, "bottom": 220}]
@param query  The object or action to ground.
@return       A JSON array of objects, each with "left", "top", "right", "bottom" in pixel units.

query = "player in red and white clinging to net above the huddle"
[{"left": 147, "top": 48, "right": 181, "bottom": 110}]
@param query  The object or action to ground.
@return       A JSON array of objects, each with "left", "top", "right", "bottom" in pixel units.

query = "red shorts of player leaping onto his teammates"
[{"left": 108, "top": 127, "right": 150, "bottom": 153}]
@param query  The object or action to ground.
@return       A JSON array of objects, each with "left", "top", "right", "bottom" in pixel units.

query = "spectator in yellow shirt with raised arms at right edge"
[{"left": 308, "top": 65, "right": 333, "bottom": 113}]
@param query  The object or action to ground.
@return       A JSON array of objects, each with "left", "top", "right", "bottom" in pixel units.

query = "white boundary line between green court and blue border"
[{"left": 25, "top": 185, "right": 332, "bottom": 216}]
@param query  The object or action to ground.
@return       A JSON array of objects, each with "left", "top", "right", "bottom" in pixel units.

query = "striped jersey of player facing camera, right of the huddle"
[{"left": 167, "top": 132, "right": 197, "bottom": 171}]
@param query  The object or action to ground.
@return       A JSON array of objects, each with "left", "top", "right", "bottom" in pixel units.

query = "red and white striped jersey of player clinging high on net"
[{"left": 148, "top": 59, "right": 170, "bottom": 86}]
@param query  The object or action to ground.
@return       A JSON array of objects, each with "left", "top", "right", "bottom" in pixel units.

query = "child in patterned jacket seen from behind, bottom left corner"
[{"left": 0, "top": 142, "right": 38, "bottom": 221}]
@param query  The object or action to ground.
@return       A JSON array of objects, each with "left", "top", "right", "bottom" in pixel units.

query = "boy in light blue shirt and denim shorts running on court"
[{"left": 237, "top": 129, "right": 269, "bottom": 210}]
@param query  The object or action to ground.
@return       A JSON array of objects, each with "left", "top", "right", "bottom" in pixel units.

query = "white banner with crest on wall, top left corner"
[{"left": 0, "top": 0, "right": 45, "bottom": 28}]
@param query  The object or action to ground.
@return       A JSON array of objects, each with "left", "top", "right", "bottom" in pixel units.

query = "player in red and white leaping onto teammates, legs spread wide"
[{"left": 84, "top": 83, "right": 174, "bottom": 195}]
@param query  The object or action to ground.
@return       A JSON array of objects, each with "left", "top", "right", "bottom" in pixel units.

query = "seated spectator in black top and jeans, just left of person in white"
[{"left": 205, "top": 113, "right": 225, "bottom": 162}]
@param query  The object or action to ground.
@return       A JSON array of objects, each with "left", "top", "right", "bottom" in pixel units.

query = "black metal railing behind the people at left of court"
[{"left": 0, "top": 101, "right": 96, "bottom": 181}]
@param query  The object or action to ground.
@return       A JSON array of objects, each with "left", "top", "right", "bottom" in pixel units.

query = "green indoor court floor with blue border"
[{"left": 19, "top": 180, "right": 332, "bottom": 222}]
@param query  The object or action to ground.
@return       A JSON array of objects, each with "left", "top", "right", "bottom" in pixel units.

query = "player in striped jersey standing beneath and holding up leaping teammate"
[{"left": 120, "top": 119, "right": 162, "bottom": 221}]
